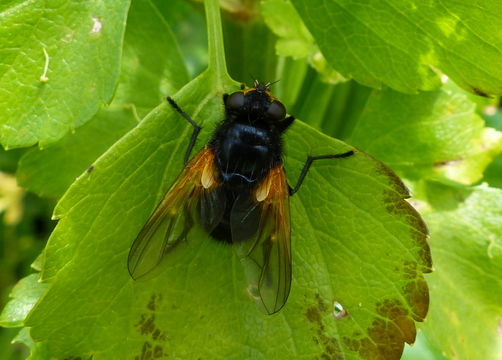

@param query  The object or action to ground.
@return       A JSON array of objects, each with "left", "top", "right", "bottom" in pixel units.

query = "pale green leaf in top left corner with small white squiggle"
[{"left": 0, "top": 0, "right": 129, "bottom": 148}]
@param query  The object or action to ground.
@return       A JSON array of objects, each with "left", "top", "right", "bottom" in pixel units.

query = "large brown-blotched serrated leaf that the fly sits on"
[{"left": 21, "top": 73, "right": 430, "bottom": 359}]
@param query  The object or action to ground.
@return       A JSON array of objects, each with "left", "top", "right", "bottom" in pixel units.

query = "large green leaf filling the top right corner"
[{"left": 291, "top": 0, "right": 502, "bottom": 95}]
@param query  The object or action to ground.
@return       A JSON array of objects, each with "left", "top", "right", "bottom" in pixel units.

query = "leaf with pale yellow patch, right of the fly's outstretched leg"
[{"left": 351, "top": 89, "right": 502, "bottom": 184}]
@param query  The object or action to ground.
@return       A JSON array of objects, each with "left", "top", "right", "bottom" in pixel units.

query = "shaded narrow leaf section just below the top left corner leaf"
[{"left": 17, "top": 107, "right": 137, "bottom": 197}]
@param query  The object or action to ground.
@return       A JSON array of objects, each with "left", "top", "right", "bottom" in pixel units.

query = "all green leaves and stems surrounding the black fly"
[{"left": 0, "top": 0, "right": 502, "bottom": 360}]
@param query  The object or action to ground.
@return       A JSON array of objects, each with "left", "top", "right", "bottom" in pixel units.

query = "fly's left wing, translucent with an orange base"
[{"left": 128, "top": 148, "right": 225, "bottom": 279}]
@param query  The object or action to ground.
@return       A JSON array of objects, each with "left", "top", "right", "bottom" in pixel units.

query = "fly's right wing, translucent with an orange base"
[{"left": 230, "top": 165, "right": 291, "bottom": 314}]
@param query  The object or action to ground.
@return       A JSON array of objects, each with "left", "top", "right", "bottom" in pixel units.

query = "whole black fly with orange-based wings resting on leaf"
[{"left": 128, "top": 81, "right": 354, "bottom": 314}]
